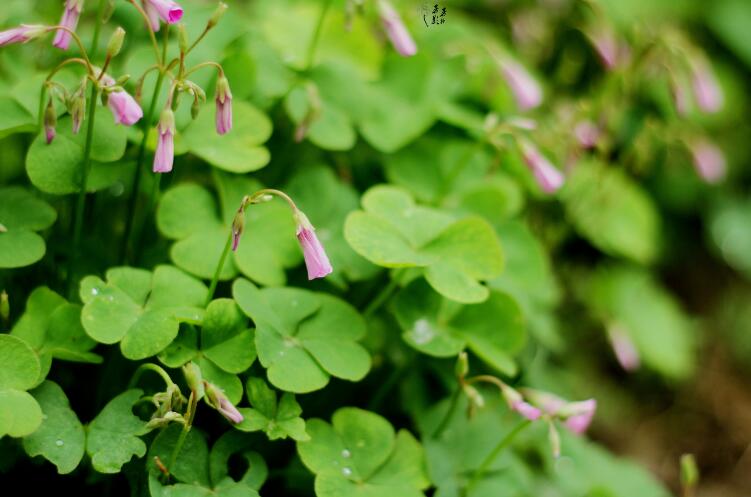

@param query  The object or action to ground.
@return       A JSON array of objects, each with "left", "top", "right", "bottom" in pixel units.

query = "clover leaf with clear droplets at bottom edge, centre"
[{"left": 297, "top": 407, "right": 429, "bottom": 497}]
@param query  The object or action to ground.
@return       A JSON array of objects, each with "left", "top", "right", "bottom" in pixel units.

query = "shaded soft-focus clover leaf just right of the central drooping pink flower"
[{"left": 285, "top": 165, "right": 378, "bottom": 284}]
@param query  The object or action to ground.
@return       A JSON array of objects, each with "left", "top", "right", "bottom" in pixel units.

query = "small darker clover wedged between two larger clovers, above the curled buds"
[{"left": 159, "top": 299, "right": 256, "bottom": 403}]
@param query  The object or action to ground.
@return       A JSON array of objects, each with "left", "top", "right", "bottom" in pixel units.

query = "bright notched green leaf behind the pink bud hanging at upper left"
[{"left": 183, "top": 101, "right": 271, "bottom": 173}]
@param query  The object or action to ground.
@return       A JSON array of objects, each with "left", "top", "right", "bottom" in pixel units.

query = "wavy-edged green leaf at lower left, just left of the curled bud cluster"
[{"left": 86, "top": 389, "right": 149, "bottom": 473}]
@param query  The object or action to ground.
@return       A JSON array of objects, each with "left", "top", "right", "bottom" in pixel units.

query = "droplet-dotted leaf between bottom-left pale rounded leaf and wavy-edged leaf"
[{"left": 23, "top": 381, "right": 86, "bottom": 474}]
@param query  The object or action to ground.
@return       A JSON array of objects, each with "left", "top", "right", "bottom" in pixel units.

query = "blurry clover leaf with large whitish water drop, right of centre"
[{"left": 393, "top": 279, "right": 526, "bottom": 375}]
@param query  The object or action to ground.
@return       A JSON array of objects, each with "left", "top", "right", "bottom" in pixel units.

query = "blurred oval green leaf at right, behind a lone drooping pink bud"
[{"left": 580, "top": 266, "right": 696, "bottom": 378}]
